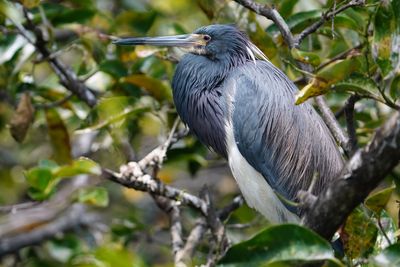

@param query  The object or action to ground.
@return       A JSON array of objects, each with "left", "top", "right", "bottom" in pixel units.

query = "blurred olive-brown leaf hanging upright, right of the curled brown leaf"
[{"left": 45, "top": 108, "right": 72, "bottom": 163}]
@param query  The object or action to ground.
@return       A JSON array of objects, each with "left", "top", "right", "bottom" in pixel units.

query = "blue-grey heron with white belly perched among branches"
[{"left": 113, "top": 24, "right": 344, "bottom": 224}]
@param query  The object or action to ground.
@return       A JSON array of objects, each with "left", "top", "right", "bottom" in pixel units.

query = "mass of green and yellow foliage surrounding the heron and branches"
[{"left": 0, "top": 0, "right": 400, "bottom": 266}]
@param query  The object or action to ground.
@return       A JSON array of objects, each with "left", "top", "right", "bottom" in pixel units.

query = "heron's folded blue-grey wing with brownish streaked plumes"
[{"left": 229, "top": 61, "right": 343, "bottom": 209}]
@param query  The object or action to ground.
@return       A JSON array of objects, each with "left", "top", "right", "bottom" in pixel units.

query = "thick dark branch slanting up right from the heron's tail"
[{"left": 304, "top": 112, "right": 400, "bottom": 240}]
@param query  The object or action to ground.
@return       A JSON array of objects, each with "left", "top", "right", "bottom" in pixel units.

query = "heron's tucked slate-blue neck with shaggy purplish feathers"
[{"left": 172, "top": 54, "right": 238, "bottom": 157}]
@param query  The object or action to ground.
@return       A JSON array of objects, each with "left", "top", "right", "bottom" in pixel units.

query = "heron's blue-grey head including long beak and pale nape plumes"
[{"left": 114, "top": 24, "right": 266, "bottom": 61}]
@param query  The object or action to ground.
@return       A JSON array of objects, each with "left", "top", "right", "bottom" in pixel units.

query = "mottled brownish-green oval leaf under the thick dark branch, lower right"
[{"left": 341, "top": 208, "right": 378, "bottom": 259}]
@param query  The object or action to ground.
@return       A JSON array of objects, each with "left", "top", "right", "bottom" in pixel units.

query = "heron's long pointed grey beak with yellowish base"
[{"left": 113, "top": 34, "right": 202, "bottom": 47}]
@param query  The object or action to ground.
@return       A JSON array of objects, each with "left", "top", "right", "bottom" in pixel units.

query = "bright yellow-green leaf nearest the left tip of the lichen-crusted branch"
[{"left": 53, "top": 157, "right": 101, "bottom": 178}]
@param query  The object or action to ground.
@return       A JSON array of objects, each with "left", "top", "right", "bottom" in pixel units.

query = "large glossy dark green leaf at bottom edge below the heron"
[{"left": 220, "top": 224, "right": 343, "bottom": 267}]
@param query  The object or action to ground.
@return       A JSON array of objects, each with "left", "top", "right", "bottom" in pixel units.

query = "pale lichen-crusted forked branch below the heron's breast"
[{"left": 102, "top": 119, "right": 243, "bottom": 267}]
